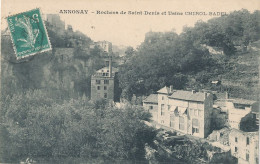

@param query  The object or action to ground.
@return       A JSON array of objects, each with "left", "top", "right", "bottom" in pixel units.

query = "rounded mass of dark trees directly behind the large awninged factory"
[{"left": 119, "top": 32, "right": 208, "bottom": 100}]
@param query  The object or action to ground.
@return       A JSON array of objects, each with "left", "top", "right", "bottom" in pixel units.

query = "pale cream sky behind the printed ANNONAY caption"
[{"left": 1, "top": 0, "right": 260, "bottom": 47}]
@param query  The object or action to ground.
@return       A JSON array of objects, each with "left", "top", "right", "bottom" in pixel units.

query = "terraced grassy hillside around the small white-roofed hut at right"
[{"left": 186, "top": 41, "right": 260, "bottom": 100}]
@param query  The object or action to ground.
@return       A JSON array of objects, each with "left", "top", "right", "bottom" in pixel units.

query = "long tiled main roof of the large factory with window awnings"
[{"left": 169, "top": 90, "right": 205, "bottom": 102}]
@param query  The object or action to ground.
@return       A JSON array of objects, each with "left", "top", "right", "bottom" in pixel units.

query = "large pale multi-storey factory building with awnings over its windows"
[{"left": 144, "top": 86, "right": 213, "bottom": 138}]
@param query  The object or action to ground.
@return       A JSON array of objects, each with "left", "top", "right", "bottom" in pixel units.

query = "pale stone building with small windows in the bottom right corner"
[{"left": 229, "top": 129, "right": 259, "bottom": 164}]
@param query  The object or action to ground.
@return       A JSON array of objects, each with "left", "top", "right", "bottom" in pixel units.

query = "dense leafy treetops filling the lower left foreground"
[{"left": 0, "top": 90, "right": 156, "bottom": 162}]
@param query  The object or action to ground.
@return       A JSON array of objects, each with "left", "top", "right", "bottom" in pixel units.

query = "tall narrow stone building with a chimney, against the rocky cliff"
[{"left": 91, "top": 57, "right": 118, "bottom": 101}]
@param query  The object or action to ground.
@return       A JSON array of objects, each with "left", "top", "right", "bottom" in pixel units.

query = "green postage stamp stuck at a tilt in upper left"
[{"left": 7, "top": 8, "right": 51, "bottom": 59}]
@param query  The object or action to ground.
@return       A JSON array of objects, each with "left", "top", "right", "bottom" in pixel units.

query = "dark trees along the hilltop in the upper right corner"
[{"left": 184, "top": 9, "right": 260, "bottom": 55}]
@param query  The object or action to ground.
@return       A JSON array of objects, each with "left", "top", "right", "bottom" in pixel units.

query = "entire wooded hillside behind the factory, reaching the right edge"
[{"left": 119, "top": 10, "right": 260, "bottom": 99}]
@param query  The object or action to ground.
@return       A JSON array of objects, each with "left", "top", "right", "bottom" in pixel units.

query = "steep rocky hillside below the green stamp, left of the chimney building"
[{"left": 1, "top": 21, "right": 104, "bottom": 98}]
